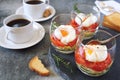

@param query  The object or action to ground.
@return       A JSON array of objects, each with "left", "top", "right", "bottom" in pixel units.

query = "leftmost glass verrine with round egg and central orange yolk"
[{"left": 50, "top": 13, "right": 80, "bottom": 54}]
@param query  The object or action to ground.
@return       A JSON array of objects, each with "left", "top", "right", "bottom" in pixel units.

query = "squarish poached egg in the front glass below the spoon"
[{"left": 84, "top": 45, "right": 107, "bottom": 62}]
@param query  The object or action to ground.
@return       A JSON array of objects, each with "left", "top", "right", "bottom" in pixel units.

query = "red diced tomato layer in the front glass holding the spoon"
[{"left": 75, "top": 47, "right": 112, "bottom": 71}]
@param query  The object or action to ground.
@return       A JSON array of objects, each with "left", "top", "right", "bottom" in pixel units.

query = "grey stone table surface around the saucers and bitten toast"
[{"left": 0, "top": 0, "right": 120, "bottom": 80}]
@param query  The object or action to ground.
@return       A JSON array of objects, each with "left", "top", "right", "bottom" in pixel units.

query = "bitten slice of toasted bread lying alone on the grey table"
[{"left": 29, "top": 56, "right": 50, "bottom": 76}]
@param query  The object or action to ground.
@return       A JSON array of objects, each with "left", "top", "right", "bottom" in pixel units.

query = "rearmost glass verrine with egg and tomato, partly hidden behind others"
[{"left": 72, "top": 4, "right": 100, "bottom": 39}]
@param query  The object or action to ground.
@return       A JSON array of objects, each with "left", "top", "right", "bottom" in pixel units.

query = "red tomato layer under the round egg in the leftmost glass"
[{"left": 50, "top": 34, "right": 77, "bottom": 47}]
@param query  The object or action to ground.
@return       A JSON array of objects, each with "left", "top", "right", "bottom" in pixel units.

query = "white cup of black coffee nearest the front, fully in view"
[{"left": 3, "top": 14, "right": 35, "bottom": 44}]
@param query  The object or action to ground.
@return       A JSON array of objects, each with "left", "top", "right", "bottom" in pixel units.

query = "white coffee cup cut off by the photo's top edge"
[{"left": 23, "top": 0, "right": 47, "bottom": 20}]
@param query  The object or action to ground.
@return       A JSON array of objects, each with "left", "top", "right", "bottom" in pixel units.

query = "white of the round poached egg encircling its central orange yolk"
[{"left": 54, "top": 25, "right": 76, "bottom": 44}]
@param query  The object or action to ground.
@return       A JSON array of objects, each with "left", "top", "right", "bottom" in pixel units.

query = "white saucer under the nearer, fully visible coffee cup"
[{"left": 0, "top": 22, "right": 45, "bottom": 49}]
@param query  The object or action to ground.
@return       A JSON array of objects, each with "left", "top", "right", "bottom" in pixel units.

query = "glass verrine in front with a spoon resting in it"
[{"left": 75, "top": 30, "right": 116, "bottom": 76}]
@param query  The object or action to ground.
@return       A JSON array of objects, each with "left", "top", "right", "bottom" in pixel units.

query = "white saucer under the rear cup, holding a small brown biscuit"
[{"left": 16, "top": 4, "right": 56, "bottom": 22}]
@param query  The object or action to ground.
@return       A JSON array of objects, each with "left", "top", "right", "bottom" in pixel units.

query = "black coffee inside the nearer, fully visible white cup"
[{"left": 7, "top": 19, "right": 30, "bottom": 27}]
